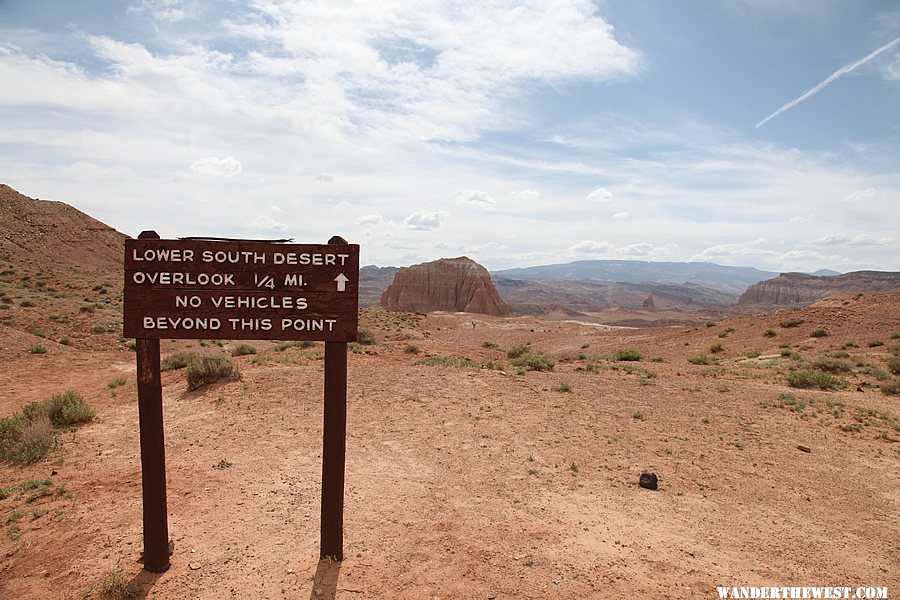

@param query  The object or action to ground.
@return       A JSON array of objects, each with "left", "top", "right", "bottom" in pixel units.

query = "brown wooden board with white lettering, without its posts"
[{"left": 124, "top": 239, "right": 359, "bottom": 342}]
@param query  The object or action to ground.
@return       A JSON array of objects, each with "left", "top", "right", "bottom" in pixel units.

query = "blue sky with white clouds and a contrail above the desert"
[{"left": 0, "top": 0, "right": 900, "bottom": 272}]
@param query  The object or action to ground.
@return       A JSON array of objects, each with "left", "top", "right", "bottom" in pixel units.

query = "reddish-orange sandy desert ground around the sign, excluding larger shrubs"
[{"left": 0, "top": 293, "right": 900, "bottom": 600}]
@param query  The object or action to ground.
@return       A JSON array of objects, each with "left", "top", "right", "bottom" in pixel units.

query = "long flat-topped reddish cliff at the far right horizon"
[{"left": 738, "top": 271, "right": 900, "bottom": 305}]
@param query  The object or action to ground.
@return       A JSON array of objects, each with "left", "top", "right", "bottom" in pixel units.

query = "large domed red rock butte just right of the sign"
[{"left": 381, "top": 256, "right": 512, "bottom": 317}]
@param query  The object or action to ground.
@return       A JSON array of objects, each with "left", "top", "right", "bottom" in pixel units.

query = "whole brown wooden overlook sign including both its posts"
[{"left": 124, "top": 231, "right": 359, "bottom": 572}]
